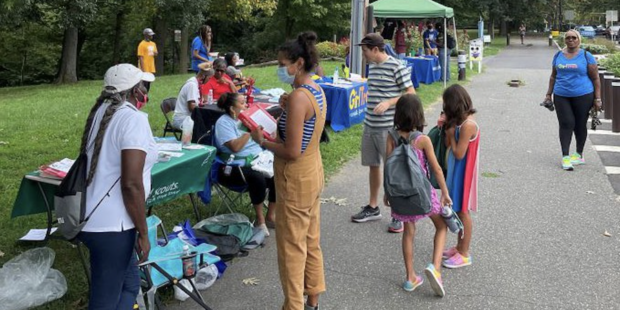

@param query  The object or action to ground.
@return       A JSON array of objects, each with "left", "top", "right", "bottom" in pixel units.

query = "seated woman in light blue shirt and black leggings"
[{"left": 215, "top": 93, "right": 276, "bottom": 236}]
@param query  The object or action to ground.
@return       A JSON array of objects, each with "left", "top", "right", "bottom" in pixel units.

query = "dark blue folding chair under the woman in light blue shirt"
[{"left": 196, "top": 126, "right": 252, "bottom": 214}]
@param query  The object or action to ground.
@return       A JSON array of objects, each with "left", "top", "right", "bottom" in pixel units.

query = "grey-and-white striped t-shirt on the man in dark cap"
[{"left": 364, "top": 56, "right": 413, "bottom": 129}]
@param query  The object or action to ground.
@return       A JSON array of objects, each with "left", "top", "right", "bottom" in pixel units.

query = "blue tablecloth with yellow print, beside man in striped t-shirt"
[{"left": 319, "top": 82, "right": 368, "bottom": 132}]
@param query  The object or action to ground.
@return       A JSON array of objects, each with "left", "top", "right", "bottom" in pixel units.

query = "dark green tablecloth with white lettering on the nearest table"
[{"left": 11, "top": 146, "right": 216, "bottom": 218}]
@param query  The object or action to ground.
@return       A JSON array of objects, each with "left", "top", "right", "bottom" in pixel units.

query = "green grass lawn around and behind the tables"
[{"left": 0, "top": 58, "right": 490, "bottom": 309}]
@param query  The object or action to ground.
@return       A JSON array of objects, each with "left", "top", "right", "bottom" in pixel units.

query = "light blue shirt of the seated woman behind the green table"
[{"left": 215, "top": 114, "right": 263, "bottom": 165}]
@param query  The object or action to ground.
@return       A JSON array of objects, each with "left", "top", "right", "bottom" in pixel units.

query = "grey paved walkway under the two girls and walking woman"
[{"left": 170, "top": 40, "right": 620, "bottom": 310}]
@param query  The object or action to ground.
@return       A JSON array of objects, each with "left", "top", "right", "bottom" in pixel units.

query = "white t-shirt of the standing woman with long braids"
[{"left": 82, "top": 102, "right": 157, "bottom": 232}]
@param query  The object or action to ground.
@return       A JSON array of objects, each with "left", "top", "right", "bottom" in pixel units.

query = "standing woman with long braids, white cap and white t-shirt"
[{"left": 78, "top": 64, "right": 157, "bottom": 310}]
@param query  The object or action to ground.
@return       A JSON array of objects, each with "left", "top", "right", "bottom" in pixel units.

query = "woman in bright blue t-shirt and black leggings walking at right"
[{"left": 545, "top": 30, "right": 601, "bottom": 171}]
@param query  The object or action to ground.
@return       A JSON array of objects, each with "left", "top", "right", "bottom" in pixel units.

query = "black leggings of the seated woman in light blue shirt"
[{"left": 218, "top": 165, "right": 276, "bottom": 205}]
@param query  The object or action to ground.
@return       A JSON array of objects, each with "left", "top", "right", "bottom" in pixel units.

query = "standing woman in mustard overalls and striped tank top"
[{"left": 252, "top": 32, "right": 327, "bottom": 310}]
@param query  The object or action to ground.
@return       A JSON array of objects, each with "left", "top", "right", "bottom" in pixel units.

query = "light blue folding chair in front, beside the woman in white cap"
[{"left": 136, "top": 215, "right": 220, "bottom": 310}]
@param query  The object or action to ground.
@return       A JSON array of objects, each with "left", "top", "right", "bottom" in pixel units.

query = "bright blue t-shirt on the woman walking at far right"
[{"left": 553, "top": 50, "right": 596, "bottom": 97}]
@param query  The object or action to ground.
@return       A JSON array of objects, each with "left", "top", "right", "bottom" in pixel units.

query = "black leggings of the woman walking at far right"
[{"left": 553, "top": 93, "right": 594, "bottom": 156}]
